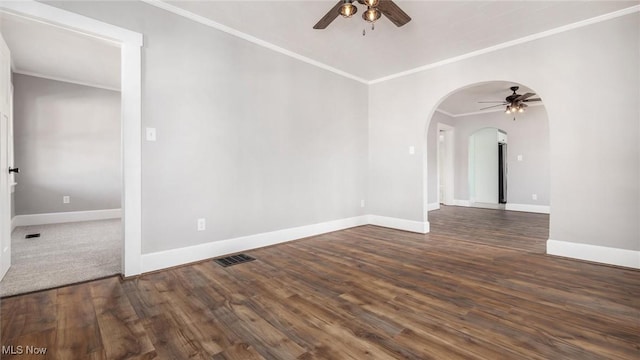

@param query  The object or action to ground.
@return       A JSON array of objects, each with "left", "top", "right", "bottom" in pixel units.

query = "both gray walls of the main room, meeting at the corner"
[{"left": 48, "top": 2, "right": 640, "bottom": 253}]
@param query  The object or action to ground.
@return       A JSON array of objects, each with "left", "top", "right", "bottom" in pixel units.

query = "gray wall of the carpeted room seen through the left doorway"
[{"left": 13, "top": 74, "right": 121, "bottom": 215}]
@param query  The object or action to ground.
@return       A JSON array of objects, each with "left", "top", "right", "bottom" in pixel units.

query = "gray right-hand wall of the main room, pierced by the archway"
[{"left": 369, "top": 13, "right": 640, "bottom": 250}]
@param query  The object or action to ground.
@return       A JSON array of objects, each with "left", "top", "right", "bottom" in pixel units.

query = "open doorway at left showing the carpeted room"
[{"left": 0, "top": 13, "right": 123, "bottom": 296}]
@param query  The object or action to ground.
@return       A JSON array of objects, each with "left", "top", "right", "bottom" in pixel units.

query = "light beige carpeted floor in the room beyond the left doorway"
[{"left": 0, "top": 219, "right": 122, "bottom": 297}]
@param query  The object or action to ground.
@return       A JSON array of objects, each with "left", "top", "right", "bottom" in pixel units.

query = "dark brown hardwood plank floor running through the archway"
[{"left": 0, "top": 208, "right": 640, "bottom": 360}]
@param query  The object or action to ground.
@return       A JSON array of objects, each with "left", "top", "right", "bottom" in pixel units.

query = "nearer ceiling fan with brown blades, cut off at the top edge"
[{"left": 313, "top": 0, "right": 411, "bottom": 29}]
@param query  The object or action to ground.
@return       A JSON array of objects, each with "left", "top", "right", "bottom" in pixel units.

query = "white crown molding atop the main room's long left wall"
[{"left": 142, "top": 0, "right": 369, "bottom": 84}]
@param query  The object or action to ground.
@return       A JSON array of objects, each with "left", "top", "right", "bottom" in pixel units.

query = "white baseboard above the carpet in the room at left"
[{"left": 11, "top": 209, "right": 122, "bottom": 228}]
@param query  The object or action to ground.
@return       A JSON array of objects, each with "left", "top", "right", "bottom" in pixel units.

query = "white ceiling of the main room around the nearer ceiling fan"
[{"left": 165, "top": 0, "right": 638, "bottom": 81}]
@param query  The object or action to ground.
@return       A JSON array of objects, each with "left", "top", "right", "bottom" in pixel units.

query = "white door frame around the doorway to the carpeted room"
[{"left": 0, "top": 0, "right": 143, "bottom": 277}]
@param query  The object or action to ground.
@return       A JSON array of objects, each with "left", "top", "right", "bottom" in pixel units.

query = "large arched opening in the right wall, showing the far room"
[{"left": 425, "top": 81, "right": 551, "bottom": 252}]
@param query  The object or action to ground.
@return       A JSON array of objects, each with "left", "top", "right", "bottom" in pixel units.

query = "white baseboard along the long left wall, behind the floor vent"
[{"left": 142, "top": 215, "right": 367, "bottom": 272}]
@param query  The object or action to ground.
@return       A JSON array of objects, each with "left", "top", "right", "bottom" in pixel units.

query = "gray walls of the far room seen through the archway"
[{"left": 428, "top": 105, "right": 550, "bottom": 206}]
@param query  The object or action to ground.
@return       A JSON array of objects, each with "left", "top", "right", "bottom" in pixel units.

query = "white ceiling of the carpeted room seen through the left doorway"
[{"left": 0, "top": 12, "right": 120, "bottom": 90}]
